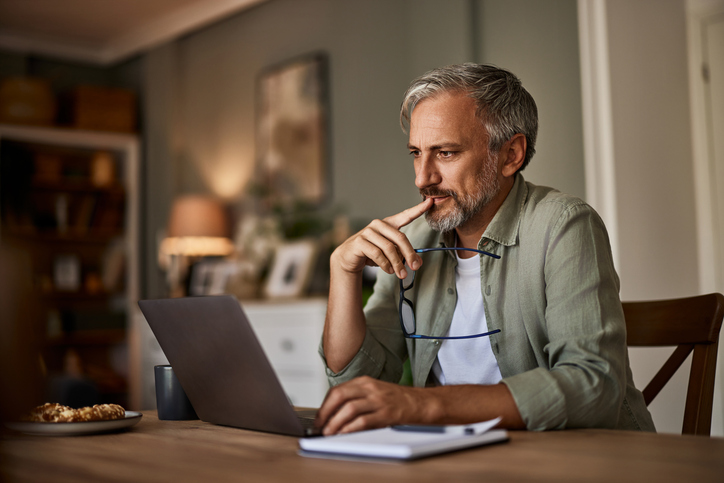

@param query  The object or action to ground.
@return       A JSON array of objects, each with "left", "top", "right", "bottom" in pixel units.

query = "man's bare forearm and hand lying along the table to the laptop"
[{"left": 316, "top": 377, "right": 525, "bottom": 435}]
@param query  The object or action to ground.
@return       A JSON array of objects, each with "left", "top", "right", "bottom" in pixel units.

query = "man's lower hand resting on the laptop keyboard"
[{"left": 315, "top": 376, "right": 435, "bottom": 436}]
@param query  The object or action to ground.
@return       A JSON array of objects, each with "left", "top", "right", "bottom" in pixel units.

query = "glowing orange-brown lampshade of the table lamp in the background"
[{"left": 161, "top": 195, "right": 234, "bottom": 256}]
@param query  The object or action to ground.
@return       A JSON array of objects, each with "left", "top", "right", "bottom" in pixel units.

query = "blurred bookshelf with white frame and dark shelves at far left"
[{"left": 0, "top": 124, "right": 139, "bottom": 407}]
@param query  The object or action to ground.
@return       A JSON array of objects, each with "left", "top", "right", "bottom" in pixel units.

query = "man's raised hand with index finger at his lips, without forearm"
[{"left": 332, "top": 198, "right": 433, "bottom": 278}]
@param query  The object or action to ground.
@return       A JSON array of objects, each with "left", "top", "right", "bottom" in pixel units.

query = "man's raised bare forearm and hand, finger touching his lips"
[{"left": 322, "top": 199, "right": 432, "bottom": 372}]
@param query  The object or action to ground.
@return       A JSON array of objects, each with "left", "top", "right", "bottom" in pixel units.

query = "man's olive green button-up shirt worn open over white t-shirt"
[{"left": 320, "top": 174, "right": 654, "bottom": 431}]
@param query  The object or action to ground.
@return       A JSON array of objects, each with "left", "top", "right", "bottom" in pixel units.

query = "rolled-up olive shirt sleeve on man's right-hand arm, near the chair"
[{"left": 503, "top": 202, "right": 626, "bottom": 430}]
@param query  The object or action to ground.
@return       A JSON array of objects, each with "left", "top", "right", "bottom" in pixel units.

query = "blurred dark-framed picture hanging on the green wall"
[{"left": 256, "top": 53, "right": 330, "bottom": 208}]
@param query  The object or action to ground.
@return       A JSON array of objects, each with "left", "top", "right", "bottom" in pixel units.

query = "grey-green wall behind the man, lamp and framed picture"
[{"left": 144, "top": 0, "right": 585, "bottom": 296}]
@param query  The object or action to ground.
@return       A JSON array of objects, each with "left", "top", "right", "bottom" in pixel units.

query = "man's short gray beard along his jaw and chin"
[{"left": 423, "top": 156, "right": 500, "bottom": 232}]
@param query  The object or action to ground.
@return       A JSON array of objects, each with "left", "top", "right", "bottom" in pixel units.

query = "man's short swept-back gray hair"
[{"left": 400, "top": 63, "right": 538, "bottom": 171}]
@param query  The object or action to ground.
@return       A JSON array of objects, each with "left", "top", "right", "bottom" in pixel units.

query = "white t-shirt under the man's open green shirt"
[{"left": 432, "top": 252, "right": 503, "bottom": 385}]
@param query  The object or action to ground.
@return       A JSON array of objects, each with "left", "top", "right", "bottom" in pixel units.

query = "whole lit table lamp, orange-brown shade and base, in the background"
[{"left": 159, "top": 195, "right": 234, "bottom": 297}]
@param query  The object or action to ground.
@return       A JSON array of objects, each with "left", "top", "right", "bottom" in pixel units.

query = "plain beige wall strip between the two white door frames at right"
[{"left": 607, "top": 0, "right": 698, "bottom": 300}]
